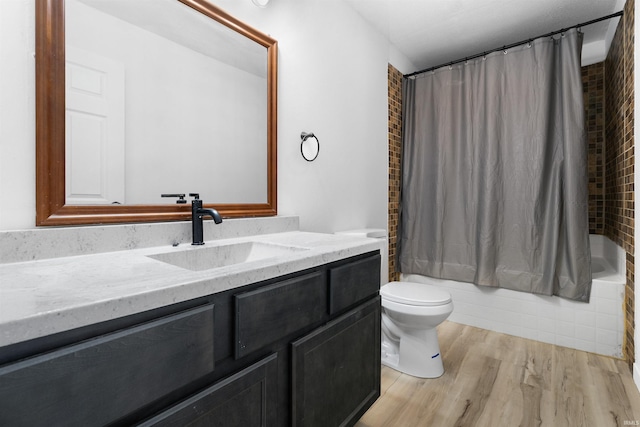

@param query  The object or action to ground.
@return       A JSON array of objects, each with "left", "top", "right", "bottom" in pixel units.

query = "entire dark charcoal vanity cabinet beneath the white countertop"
[{"left": 0, "top": 252, "right": 380, "bottom": 427}]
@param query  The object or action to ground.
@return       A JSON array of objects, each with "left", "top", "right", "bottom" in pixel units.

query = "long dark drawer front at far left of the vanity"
[{"left": 0, "top": 304, "right": 214, "bottom": 426}]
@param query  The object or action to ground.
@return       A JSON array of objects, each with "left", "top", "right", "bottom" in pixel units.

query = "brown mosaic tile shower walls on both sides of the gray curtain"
[{"left": 388, "top": 0, "right": 635, "bottom": 366}]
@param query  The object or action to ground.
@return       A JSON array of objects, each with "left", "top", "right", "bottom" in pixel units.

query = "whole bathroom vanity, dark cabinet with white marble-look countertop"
[{"left": 0, "top": 226, "right": 380, "bottom": 427}]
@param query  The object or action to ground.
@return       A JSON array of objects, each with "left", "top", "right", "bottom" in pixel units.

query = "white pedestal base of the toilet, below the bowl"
[{"left": 381, "top": 328, "right": 444, "bottom": 378}]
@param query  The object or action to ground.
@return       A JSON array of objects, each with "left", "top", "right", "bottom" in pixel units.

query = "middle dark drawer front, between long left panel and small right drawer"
[{"left": 235, "top": 271, "right": 327, "bottom": 359}]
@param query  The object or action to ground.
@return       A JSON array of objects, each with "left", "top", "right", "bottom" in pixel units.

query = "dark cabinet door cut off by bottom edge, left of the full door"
[{"left": 141, "top": 354, "right": 278, "bottom": 427}]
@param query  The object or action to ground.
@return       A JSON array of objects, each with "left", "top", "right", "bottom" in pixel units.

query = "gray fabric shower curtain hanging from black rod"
[{"left": 398, "top": 30, "right": 591, "bottom": 302}]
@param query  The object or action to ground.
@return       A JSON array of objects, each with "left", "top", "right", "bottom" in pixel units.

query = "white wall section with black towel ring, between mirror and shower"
[{"left": 216, "top": 0, "right": 389, "bottom": 232}]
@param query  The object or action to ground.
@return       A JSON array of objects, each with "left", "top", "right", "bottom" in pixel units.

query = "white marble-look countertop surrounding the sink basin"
[{"left": 0, "top": 231, "right": 383, "bottom": 347}]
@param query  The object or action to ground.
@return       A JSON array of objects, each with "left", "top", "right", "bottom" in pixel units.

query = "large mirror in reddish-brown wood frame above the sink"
[{"left": 36, "top": 0, "right": 277, "bottom": 226}]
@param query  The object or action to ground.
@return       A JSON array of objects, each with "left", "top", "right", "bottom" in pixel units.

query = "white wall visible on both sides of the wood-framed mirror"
[{"left": 0, "top": 0, "right": 400, "bottom": 232}]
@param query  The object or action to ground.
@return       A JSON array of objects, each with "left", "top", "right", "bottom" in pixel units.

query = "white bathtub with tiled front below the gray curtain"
[{"left": 400, "top": 235, "right": 625, "bottom": 358}]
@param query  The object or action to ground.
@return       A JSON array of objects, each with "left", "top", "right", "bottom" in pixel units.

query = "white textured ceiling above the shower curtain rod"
[{"left": 345, "top": 0, "right": 624, "bottom": 72}]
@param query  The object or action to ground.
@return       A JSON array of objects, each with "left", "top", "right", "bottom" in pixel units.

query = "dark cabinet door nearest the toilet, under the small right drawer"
[{"left": 291, "top": 297, "right": 380, "bottom": 427}]
